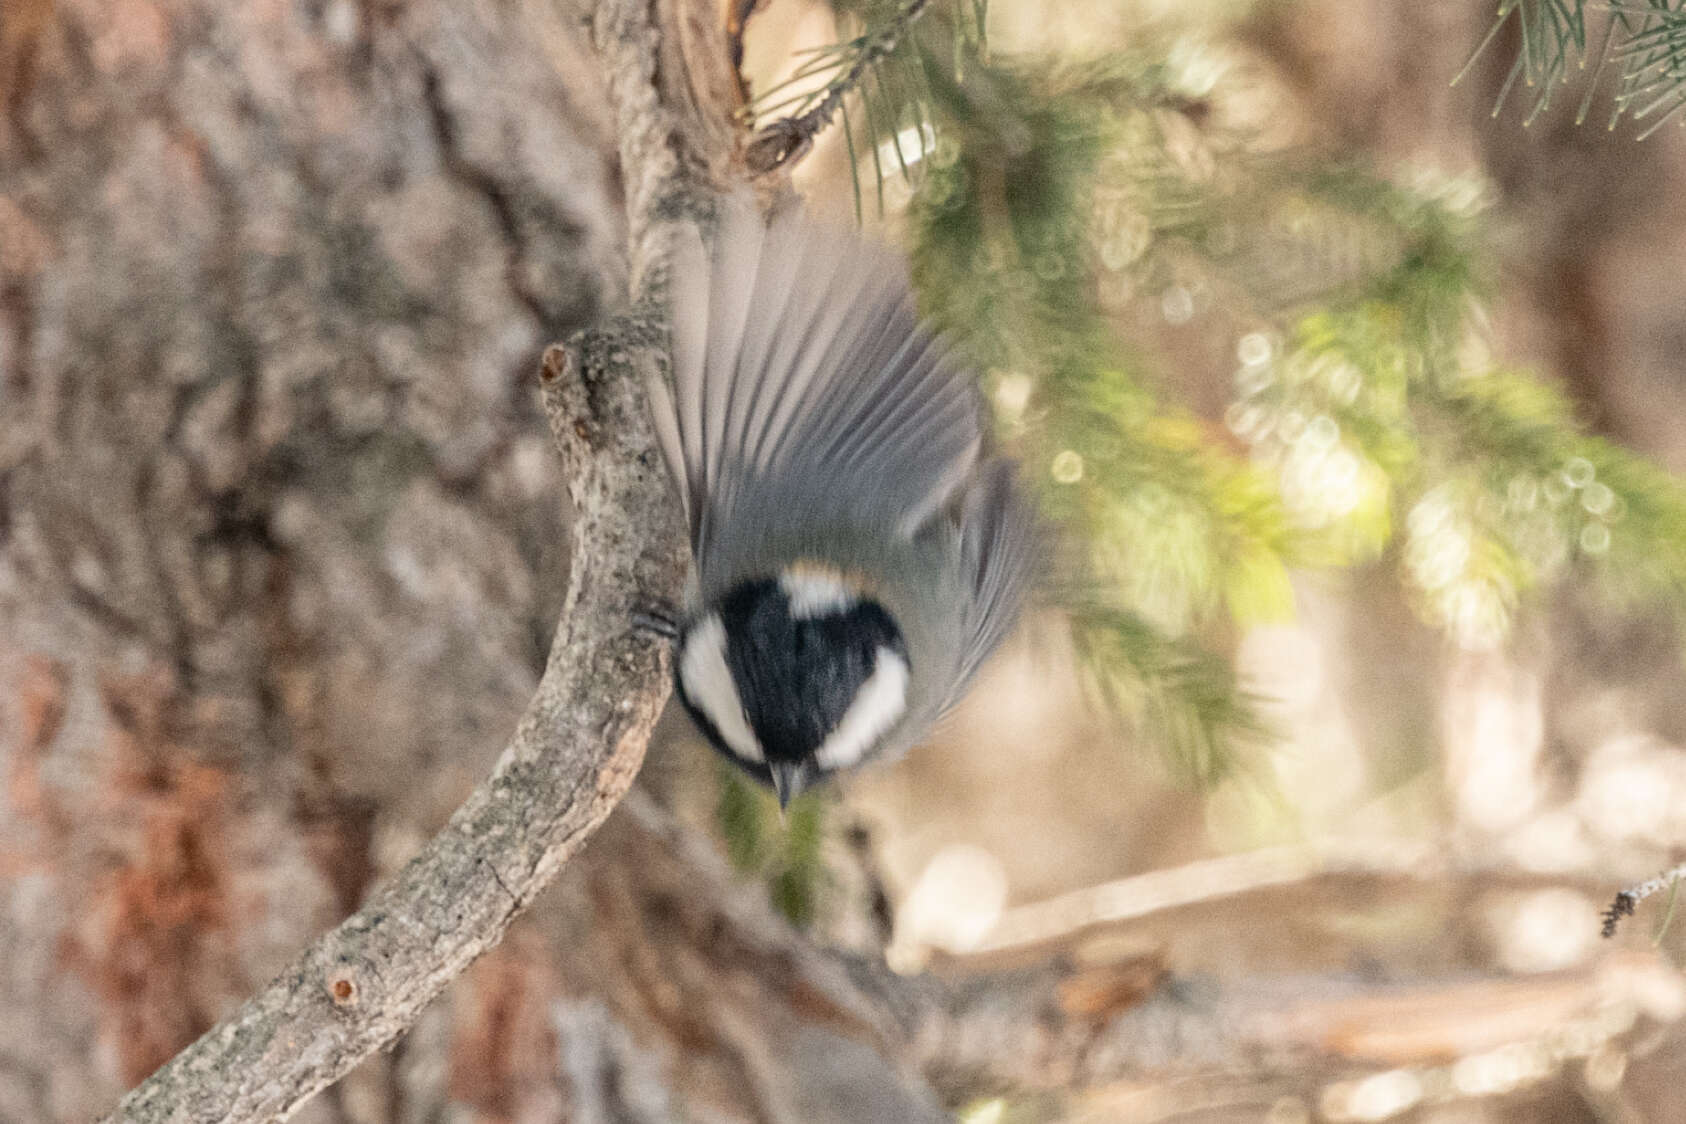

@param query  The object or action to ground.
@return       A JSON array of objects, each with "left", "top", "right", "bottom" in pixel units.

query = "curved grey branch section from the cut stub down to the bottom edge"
[{"left": 106, "top": 335, "right": 685, "bottom": 1124}]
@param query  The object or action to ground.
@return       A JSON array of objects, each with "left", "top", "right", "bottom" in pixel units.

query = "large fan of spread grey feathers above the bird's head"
[{"left": 651, "top": 197, "right": 983, "bottom": 573}]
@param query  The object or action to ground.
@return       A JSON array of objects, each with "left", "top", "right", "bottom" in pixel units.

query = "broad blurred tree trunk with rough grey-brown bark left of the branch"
[{"left": 0, "top": 0, "right": 624, "bottom": 1121}]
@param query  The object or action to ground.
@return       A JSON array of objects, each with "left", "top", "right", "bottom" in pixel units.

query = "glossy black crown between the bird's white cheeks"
[{"left": 717, "top": 578, "right": 907, "bottom": 762}]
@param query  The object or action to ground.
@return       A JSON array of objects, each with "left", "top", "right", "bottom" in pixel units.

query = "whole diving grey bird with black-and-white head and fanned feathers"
[{"left": 647, "top": 195, "right": 1040, "bottom": 809}]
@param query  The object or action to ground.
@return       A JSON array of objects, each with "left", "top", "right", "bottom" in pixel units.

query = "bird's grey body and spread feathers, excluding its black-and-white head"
[{"left": 651, "top": 197, "right": 1035, "bottom": 795}]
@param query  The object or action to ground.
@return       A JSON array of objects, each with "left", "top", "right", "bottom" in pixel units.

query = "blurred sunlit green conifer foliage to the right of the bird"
[{"left": 747, "top": 0, "right": 1686, "bottom": 782}]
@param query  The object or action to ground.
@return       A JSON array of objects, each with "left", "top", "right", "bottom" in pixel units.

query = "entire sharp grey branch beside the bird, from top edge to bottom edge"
[{"left": 92, "top": 0, "right": 732, "bottom": 1124}]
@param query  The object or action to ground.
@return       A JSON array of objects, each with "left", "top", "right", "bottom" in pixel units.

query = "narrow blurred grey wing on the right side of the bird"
[{"left": 942, "top": 460, "right": 1042, "bottom": 711}]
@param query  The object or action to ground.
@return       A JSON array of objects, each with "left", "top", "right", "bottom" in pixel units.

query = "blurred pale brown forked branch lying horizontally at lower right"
[{"left": 600, "top": 792, "right": 1686, "bottom": 1121}]
